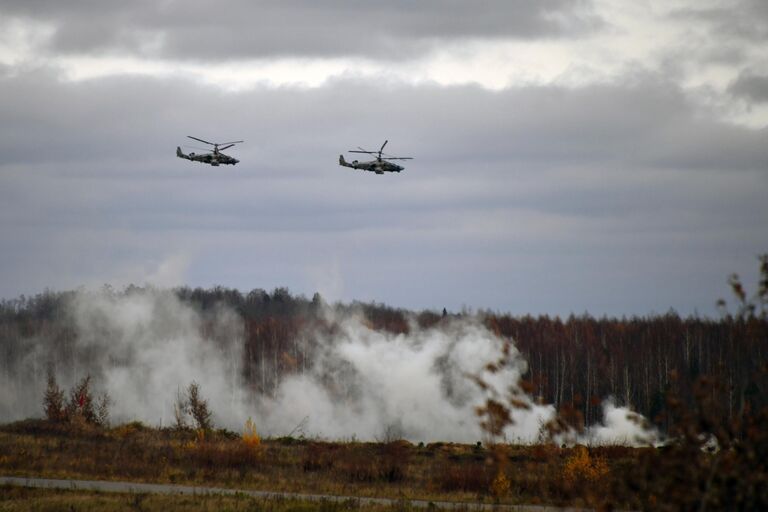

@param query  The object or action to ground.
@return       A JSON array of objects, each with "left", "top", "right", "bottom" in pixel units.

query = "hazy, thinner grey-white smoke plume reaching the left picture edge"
[{"left": 0, "top": 289, "right": 243, "bottom": 426}]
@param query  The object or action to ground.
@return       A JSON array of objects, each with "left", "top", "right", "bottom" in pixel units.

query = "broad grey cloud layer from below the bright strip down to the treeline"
[{"left": 0, "top": 72, "right": 768, "bottom": 314}]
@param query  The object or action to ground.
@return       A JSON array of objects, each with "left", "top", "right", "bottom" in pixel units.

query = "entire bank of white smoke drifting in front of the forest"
[{"left": 0, "top": 289, "right": 656, "bottom": 443}]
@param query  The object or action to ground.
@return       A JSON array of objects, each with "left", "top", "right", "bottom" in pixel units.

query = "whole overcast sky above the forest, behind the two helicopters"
[{"left": 0, "top": 0, "right": 768, "bottom": 315}]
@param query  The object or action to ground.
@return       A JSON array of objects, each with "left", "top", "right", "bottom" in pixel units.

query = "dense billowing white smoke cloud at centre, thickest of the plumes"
[{"left": 255, "top": 317, "right": 554, "bottom": 441}]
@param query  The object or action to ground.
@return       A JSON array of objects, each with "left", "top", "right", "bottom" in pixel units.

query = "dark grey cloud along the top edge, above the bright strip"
[{"left": 0, "top": 0, "right": 601, "bottom": 60}]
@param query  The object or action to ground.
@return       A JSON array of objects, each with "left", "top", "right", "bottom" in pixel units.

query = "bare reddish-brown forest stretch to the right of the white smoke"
[{"left": 486, "top": 312, "right": 768, "bottom": 427}]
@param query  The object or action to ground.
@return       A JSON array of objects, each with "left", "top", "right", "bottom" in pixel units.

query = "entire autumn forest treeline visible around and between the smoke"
[{"left": 0, "top": 286, "right": 768, "bottom": 428}]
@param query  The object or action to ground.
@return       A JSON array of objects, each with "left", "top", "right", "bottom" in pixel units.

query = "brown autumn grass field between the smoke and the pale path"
[{"left": 0, "top": 420, "right": 643, "bottom": 506}]
